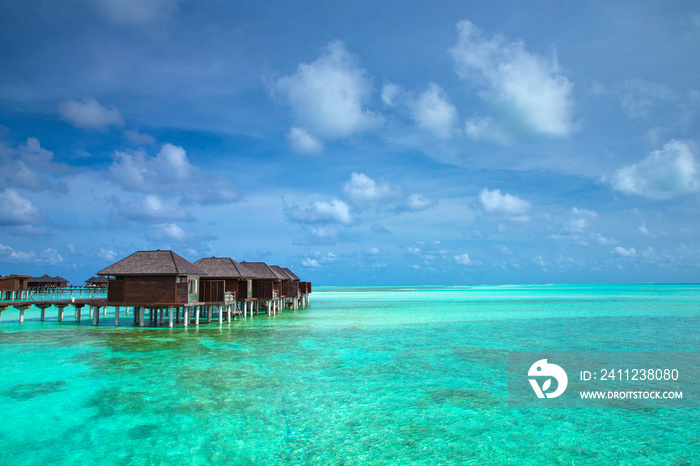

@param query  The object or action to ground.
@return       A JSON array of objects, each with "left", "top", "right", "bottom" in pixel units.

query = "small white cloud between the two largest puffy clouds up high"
[{"left": 407, "top": 83, "right": 459, "bottom": 139}]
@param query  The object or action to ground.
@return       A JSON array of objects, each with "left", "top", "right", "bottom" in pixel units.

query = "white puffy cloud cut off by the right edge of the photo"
[{"left": 603, "top": 140, "right": 700, "bottom": 200}]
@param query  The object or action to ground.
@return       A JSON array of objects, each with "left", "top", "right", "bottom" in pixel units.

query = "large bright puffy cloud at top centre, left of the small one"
[{"left": 275, "top": 41, "right": 382, "bottom": 145}]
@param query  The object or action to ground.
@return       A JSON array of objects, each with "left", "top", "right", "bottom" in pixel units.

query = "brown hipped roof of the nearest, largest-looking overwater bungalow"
[{"left": 97, "top": 249, "right": 206, "bottom": 276}]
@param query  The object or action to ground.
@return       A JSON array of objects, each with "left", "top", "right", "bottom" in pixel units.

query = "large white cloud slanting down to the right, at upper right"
[{"left": 450, "top": 21, "right": 574, "bottom": 137}]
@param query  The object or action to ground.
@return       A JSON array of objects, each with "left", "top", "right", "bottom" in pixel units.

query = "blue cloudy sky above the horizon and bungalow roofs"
[{"left": 0, "top": 0, "right": 700, "bottom": 285}]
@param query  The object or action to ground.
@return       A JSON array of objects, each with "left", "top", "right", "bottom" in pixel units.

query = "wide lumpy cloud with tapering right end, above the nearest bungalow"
[{"left": 109, "top": 144, "right": 240, "bottom": 204}]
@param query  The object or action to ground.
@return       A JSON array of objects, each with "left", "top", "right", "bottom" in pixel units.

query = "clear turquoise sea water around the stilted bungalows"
[{"left": 0, "top": 285, "right": 700, "bottom": 465}]
